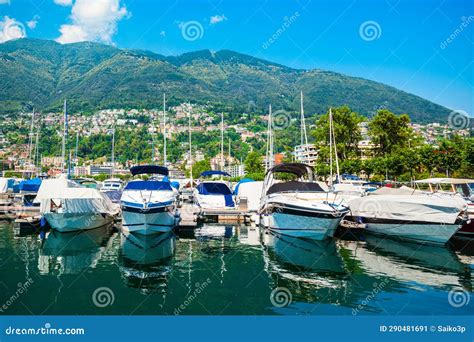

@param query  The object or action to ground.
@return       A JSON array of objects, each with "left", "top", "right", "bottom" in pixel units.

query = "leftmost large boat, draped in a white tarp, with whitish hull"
[{"left": 34, "top": 174, "right": 119, "bottom": 232}]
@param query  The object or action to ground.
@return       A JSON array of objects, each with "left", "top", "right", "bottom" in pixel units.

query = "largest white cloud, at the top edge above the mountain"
[{"left": 56, "top": 0, "right": 129, "bottom": 44}]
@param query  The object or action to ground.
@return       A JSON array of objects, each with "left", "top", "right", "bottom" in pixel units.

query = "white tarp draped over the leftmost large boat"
[{"left": 35, "top": 176, "right": 117, "bottom": 215}]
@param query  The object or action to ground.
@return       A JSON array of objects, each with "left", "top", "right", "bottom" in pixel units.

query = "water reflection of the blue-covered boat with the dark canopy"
[{"left": 119, "top": 230, "right": 176, "bottom": 293}]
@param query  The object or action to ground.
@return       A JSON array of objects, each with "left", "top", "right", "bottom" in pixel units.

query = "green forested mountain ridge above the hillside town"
[{"left": 0, "top": 39, "right": 450, "bottom": 122}]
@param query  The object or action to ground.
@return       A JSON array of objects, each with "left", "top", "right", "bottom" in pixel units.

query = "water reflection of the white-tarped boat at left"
[{"left": 38, "top": 225, "right": 113, "bottom": 275}]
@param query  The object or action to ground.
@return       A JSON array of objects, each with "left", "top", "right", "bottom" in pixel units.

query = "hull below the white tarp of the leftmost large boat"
[{"left": 43, "top": 213, "right": 113, "bottom": 233}]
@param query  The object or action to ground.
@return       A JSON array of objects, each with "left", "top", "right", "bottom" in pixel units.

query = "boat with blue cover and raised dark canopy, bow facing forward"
[{"left": 120, "top": 165, "right": 180, "bottom": 235}]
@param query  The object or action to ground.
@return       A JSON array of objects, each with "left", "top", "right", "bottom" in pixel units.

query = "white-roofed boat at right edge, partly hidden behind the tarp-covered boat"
[{"left": 414, "top": 178, "right": 474, "bottom": 239}]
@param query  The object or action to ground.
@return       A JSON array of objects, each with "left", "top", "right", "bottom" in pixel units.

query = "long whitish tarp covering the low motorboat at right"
[{"left": 349, "top": 194, "right": 467, "bottom": 224}]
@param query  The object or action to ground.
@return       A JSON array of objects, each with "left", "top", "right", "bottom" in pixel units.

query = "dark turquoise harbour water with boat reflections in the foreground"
[{"left": 0, "top": 223, "right": 474, "bottom": 315}]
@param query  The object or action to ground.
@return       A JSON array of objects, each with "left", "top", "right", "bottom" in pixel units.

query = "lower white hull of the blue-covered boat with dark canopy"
[{"left": 122, "top": 208, "right": 177, "bottom": 235}]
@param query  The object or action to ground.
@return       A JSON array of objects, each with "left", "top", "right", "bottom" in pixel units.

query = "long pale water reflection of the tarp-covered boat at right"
[{"left": 341, "top": 235, "right": 470, "bottom": 290}]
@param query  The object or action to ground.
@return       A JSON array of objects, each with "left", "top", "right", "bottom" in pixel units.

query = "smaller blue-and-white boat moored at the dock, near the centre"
[{"left": 193, "top": 171, "right": 235, "bottom": 210}]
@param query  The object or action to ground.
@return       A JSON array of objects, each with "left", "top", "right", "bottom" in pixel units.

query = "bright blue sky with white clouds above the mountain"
[{"left": 0, "top": 0, "right": 474, "bottom": 116}]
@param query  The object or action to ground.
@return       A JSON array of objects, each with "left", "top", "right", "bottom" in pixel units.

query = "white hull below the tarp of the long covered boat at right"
[{"left": 366, "top": 222, "right": 462, "bottom": 245}]
